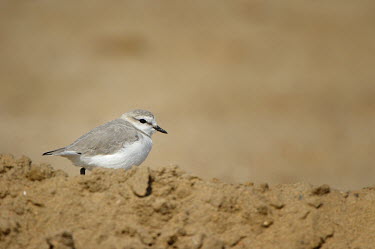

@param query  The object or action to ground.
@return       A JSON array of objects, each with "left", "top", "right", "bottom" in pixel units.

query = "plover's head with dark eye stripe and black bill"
[{"left": 121, "top": 110, "right": 167, "bottom": 136}]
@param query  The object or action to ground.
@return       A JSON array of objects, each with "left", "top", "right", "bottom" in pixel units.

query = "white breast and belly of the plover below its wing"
[{"left": 76, "top": 135, "right": 152, "bottom": 169}]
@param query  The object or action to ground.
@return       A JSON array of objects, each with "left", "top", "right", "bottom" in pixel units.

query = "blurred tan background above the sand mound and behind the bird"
[{"left": 0, "top": 0, "right": 375, "bottom": 189}]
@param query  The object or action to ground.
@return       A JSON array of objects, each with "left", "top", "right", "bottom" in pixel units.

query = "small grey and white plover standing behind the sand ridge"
[{"left": 42, "top": 109, "right": 168, "bottom": 175}]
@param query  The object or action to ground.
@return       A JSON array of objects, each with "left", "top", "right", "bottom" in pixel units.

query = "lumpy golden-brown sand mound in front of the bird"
[{"left": 0, "top": 155, "right": 375, "bottom": 249}]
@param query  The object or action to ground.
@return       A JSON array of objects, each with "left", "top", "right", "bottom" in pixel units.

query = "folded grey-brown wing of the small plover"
[{"left": 65, "top": 119, "right": 139, "bottom": 156}]
